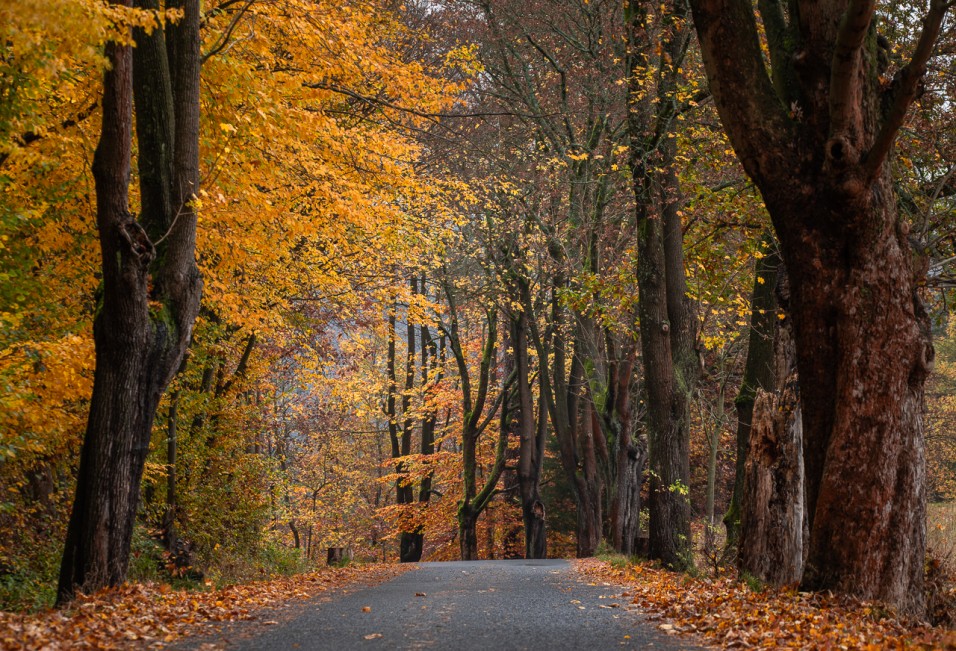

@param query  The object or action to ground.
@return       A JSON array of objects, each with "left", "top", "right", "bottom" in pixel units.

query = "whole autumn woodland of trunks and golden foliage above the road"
[{"left": 0, "top": 0, "right": 956, "bottom": 636}]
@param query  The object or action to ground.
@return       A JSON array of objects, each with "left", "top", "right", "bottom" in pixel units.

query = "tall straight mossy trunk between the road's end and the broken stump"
[{"left": 628, "top": 2, "right": 697, "bottom": 568}]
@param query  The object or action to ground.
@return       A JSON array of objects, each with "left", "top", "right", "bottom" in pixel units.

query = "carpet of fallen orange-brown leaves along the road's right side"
[{"left": 576, "top": 559, "right": 956, "bottom": 651}]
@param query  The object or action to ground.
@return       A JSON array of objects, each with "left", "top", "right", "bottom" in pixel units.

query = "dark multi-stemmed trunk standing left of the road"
[{"left": 57, "top": 0, "right": 202, "bottom": 604}]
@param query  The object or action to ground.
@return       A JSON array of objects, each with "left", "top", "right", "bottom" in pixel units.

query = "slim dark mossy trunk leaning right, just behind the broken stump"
[{"left": 724, "top": 236, "right": 780, "bottom": 555}]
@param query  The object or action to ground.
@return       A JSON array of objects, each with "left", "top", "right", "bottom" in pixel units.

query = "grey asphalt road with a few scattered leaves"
[{"left": 230, "top": 560, "right": 695, "bottom": 651}]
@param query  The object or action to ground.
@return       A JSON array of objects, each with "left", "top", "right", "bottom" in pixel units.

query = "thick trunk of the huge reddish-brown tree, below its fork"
[{"left": 788, "top": 185, "right": 933, "bottom": 612}]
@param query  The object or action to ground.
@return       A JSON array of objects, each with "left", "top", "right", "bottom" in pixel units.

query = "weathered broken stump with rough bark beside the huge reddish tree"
[{"left": 738, "top": 269, "right": 809, "bottom": 586}]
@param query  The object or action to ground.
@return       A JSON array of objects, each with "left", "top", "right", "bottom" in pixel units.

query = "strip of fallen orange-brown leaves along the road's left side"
[{"left": 0, "top": 565, "right": 410, "bottom": 651}]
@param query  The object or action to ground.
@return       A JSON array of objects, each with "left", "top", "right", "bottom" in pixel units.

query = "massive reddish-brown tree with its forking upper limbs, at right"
[{"left": 691, "top": 0, "right": 950, "bottom": 613}]
